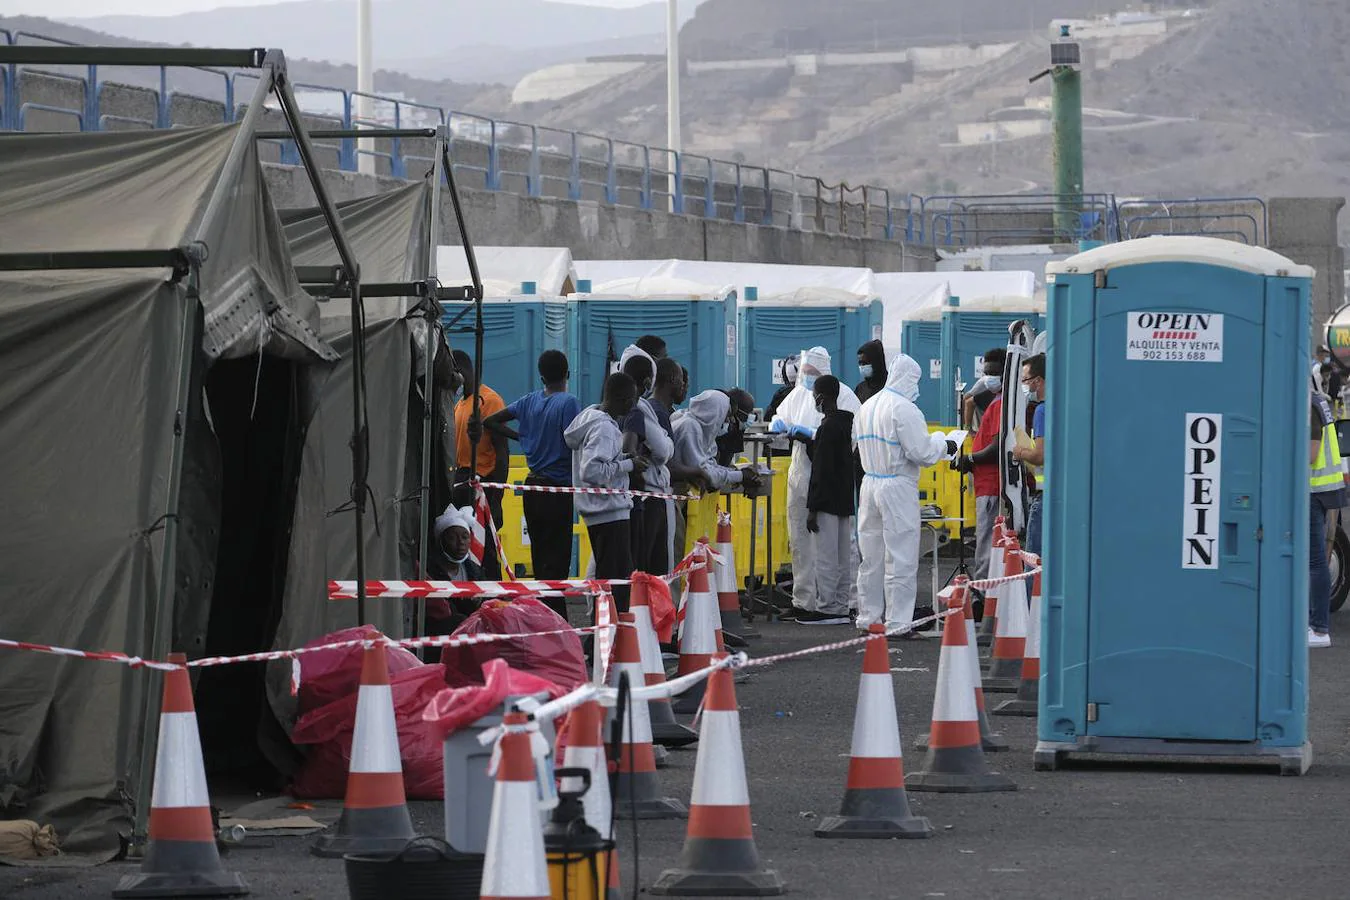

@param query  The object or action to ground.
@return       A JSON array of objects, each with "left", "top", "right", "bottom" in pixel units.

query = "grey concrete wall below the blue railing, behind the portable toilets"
[{"left": 267, "top": 165, "right": 937, "bottom": 271}]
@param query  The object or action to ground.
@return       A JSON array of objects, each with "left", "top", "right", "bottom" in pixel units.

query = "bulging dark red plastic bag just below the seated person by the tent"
[{"left": 440, "top": 596, "right": 589, "bottom": 691}]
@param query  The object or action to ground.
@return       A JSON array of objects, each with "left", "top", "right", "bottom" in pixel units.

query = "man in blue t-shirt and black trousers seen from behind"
[{"left": 483, "top": 349, "right": 582, "bottom": 580}]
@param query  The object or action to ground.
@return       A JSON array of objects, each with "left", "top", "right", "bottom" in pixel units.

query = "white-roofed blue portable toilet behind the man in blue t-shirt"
[{"left": 436, "top": 247, "right": 575, "bottom": 403}]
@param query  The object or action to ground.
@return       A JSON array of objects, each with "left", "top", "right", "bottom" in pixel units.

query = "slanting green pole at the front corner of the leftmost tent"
[{"left": 131, "top": 264, "right": 201, "bottom": 855}]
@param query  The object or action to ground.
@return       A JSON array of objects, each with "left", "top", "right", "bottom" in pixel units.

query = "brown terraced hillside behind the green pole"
[{"left": 518, "top": 0, "right": 1350, "bottom": 238}]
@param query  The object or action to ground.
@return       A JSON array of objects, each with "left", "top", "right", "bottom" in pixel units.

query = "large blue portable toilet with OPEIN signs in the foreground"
[{"left": 1035, "top": 236, "right": 1312, "bottom": 773}]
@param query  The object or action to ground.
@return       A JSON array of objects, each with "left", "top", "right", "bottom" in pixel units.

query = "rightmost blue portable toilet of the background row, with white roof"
[{"left": 939, "top": 297, "right": 1045, "bottom": 425}]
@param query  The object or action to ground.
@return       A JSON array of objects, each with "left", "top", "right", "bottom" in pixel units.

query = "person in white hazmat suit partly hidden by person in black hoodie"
[{"left": 770, "top": 347, "right": 864, "bottom": 618}]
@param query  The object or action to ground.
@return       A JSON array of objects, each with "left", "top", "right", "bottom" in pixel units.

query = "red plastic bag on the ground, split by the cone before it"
[{"left": 290, "top": 664, "right": 446, "bottom": 800}]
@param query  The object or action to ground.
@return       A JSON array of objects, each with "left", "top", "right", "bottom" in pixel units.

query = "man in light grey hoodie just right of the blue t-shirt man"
[{"left": 563, "top": 372, "right": 648, "bottom": 613}]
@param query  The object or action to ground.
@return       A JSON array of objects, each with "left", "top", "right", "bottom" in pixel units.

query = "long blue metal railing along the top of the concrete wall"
[{"left": 15, "top": 28, "right": 1285, "bottom": 246}]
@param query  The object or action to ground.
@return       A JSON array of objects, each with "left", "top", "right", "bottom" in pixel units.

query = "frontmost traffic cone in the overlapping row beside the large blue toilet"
[{"left": 905, "top": 584, "right": 1017, "bottom": 793}]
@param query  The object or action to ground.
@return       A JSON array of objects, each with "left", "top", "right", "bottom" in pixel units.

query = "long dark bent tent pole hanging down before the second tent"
[{"left": 271, "top": 50, "right": 370, "bottom": 625}]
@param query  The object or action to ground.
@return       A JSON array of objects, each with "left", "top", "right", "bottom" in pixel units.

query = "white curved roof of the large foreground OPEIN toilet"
[{"left": 1045, "top": 235, "right": 1314, "bottom": 278}]
